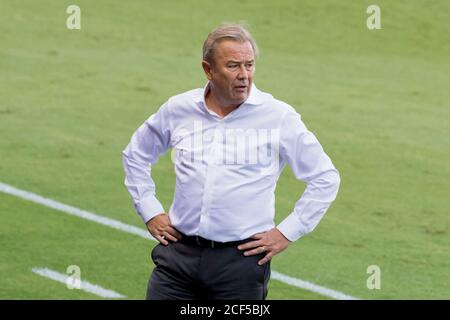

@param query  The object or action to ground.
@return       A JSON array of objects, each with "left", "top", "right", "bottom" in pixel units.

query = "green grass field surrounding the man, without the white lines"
[{"left": 0, "top": 0, "right": 450, "bottom": 299}]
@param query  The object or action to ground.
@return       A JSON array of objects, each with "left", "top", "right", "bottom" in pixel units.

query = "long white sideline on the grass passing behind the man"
[{"left": 0, "top": 182, "right": 358, "bottom": 300}]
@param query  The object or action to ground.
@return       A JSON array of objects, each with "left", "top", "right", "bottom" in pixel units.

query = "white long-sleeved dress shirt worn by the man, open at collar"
[{"left": 123, "top": 85, "right": 340, "bottom": 242}]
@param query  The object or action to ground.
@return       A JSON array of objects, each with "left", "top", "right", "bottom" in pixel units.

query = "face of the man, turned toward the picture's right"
[{"left": 203, "top": 40, "right": 255, "bottom": 106}]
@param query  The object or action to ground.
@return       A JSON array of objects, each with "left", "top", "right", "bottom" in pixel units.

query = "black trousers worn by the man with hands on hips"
[{"left": 147, "top": 236, "right": 270, "bottom": 300}]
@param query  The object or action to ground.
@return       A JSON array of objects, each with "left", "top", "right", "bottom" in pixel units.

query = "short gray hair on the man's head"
[{"left": 203, "top": 23, "right": 259, "bottom": 62}]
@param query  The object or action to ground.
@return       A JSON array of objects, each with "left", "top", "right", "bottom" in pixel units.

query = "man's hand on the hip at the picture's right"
[{"left": 238, "top": 228, "right": 291, "bottom": 265}]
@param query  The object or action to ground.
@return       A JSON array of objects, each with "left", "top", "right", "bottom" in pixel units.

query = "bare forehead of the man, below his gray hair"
[{"left": 215, "top": 40, "right": 255, "bottom": 61}]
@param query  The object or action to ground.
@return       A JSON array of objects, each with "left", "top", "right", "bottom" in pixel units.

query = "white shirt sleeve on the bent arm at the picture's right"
[{"left": 277, "top": 111, "right": 340, "bottom": 241}]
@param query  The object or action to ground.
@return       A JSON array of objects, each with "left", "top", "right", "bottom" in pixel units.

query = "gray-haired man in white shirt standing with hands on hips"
[{"left": 123, "top": 24, "right": 340, "bottom": 299}]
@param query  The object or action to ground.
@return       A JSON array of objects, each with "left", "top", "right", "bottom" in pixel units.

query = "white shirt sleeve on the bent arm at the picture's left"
[{"left": 122, "top": 103, "right": 170, "bottom": 223}]
